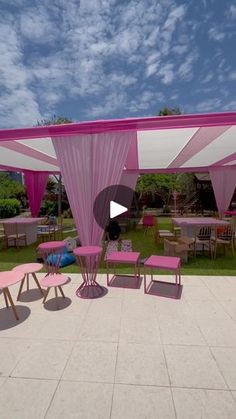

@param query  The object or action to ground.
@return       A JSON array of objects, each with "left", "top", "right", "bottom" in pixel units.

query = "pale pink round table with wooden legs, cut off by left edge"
[{"left": 0, "top": 271, "right": 25, "bottom": 320}]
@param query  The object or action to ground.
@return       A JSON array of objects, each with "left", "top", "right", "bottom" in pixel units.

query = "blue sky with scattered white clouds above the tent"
[{"left": 0, "top": 0, "right": 236, "bottom": 128}]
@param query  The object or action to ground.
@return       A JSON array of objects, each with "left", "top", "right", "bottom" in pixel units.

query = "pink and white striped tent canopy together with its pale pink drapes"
[{"left": 0, "top": 112, "right": 236, "bottom": 244}]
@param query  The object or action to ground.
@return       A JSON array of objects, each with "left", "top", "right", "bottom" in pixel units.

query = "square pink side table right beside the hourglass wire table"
[{"left": 106, "top": 252, "right": 140, "bottom": 286}]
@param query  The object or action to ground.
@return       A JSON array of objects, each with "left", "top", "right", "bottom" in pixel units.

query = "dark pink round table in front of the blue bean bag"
[{"left": 38, "top": 241, "right": 65, "bottom": 274}]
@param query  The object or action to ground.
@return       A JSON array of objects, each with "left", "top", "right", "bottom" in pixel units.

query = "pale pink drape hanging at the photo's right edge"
[{"left": 209, "top": 167, "right": 236, "bottom": 217}]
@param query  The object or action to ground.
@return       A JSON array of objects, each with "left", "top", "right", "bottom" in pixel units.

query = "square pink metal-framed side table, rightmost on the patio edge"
[{"left": 144, "top": 255, "right": 181, "bottom": 295}]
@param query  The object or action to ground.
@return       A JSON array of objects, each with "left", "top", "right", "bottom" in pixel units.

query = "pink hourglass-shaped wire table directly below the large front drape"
[{"left": 73, "top": 246, "right": 104, "bottom": 298}]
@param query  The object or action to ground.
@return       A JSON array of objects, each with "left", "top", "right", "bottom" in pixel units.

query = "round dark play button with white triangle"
[{"left": 93, "top": 185, "right": 139, "bottom": 229}]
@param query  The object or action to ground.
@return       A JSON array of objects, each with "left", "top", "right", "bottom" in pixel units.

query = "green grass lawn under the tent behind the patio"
[{"left": 0, "top": 217, "right": 236, "bottom": 276}]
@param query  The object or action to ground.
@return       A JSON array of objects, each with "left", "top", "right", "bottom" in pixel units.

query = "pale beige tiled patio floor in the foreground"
[{"left": 0, "top": 274, "right": 236, "bottom": 419}]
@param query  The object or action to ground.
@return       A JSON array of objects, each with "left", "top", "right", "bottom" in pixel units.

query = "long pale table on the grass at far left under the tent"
[{"left": 1, "top": 217, "right": 42, "bottom": 246}]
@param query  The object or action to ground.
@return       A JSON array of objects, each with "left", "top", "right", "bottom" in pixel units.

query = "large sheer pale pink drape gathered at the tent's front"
[{"left": 53, "top": 132, "right": 136, "bottom": 246}]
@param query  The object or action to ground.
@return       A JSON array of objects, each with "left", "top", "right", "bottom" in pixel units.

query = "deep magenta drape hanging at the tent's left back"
[{"left": 24, "top": 172, "right": 48, "bottom": 217}]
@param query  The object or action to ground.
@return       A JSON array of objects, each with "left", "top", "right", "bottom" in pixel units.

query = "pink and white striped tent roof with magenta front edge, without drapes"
[{"left": 0, "top": 112, "right": 236, "bottom": 173}]
